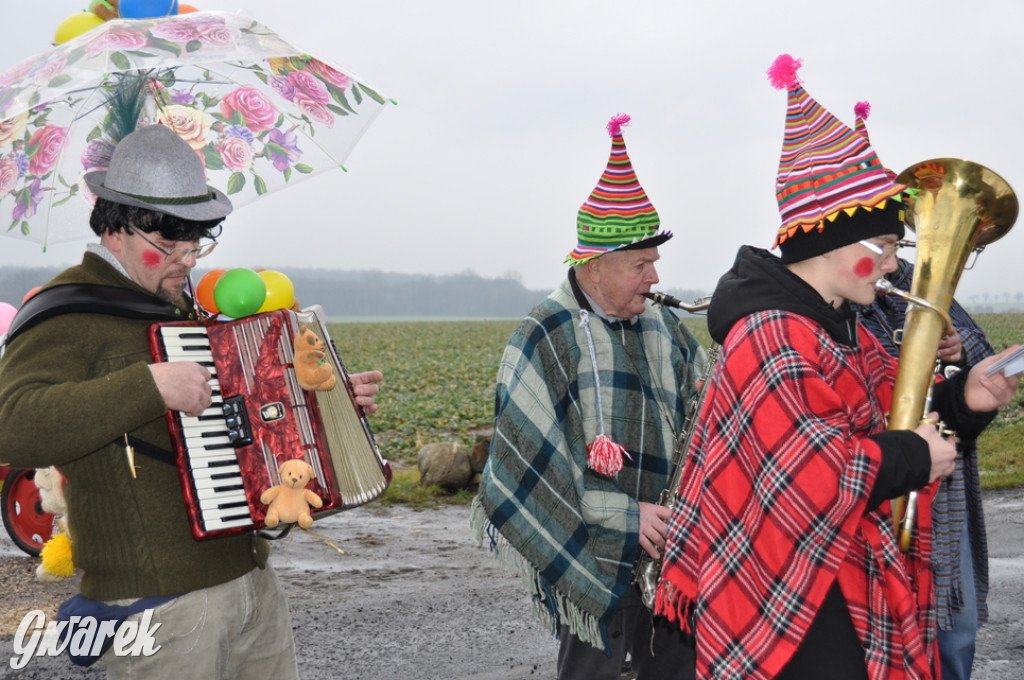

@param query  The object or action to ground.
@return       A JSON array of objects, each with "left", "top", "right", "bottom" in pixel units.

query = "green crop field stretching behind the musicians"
[{"left": 330, "top": 313, "right": 1024, "bottom": 505}]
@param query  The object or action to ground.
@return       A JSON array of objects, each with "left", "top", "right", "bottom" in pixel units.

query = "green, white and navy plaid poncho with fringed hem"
[{"left": 471, "top": 282, "right": 701, "bottom": 651}]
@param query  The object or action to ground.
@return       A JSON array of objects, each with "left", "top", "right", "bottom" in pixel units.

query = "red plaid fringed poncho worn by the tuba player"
[{"left": 655, "top": 310, "right": 935, "bottom": 680}]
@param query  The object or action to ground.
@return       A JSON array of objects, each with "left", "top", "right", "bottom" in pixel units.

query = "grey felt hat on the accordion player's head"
[{"left": 84, "top": 125, "right": 231, "bottom": 220}]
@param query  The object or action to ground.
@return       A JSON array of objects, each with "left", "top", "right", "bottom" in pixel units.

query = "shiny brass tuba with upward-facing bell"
[{"left": 880, "top": 158, "right": 1018, "bottom": 552}]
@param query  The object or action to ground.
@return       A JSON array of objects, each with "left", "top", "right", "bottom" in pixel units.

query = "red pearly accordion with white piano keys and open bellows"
[{"left": 150, "top": 307, "right": 391, "bottom": 539}]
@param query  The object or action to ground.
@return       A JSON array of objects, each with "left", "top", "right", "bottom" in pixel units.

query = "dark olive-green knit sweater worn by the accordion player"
[{"left": 0, "top": 253, "right": 269, "bottom": 600}]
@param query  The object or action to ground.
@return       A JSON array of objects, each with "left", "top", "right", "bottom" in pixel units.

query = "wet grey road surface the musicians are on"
[{"left": 0, "top": 490, "right": 1024, "bottom": 680}]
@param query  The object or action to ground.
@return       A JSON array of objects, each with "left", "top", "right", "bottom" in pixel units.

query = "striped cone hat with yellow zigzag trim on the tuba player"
[{"left": 768, "top": 54, "right": 906, "bottom": 257}]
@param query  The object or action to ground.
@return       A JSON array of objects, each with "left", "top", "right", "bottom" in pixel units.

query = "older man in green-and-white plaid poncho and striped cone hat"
[{"left": 472, "top": 117, "right": 702, "bottom": 680}]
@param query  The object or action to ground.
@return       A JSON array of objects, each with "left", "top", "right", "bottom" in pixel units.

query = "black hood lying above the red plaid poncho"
[{"left": 708, "top": 246, "right": 857, "bottom": 346}]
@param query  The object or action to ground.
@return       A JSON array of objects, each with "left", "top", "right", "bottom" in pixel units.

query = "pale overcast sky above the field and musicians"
[{"left": 0, "top": 0, "right": 1024, "bottom": 301}]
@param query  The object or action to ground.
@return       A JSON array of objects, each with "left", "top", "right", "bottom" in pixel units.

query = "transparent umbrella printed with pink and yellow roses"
[{"left": 0, "top": 12, "right": 387, "bottom": 249}]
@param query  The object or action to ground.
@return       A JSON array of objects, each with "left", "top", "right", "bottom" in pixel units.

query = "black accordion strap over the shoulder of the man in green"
[{"left": 3, "top": 284, "right": 185, "bottom": 345}]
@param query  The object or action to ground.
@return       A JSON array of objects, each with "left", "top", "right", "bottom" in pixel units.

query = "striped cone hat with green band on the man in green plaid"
[{"left": 564, "top": 114, "right": 672, "bottom": 266}]
